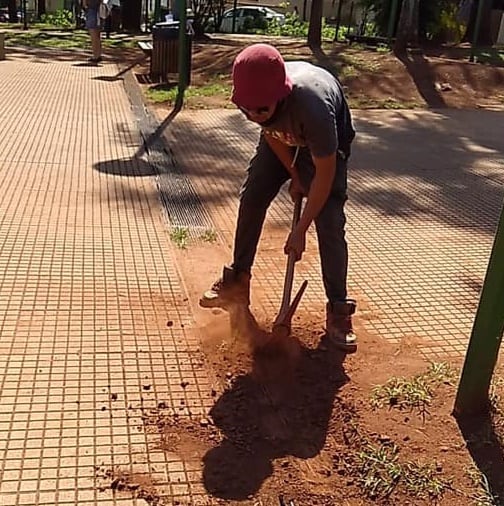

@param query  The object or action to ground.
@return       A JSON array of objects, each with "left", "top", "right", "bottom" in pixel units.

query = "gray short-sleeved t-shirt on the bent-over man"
[{"left": 263, "top": 62, "right": 355, "bottom": 157}]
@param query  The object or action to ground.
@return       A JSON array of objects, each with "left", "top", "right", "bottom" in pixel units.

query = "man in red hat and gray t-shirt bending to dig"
[{"left": 200, "top": 44, "right": 356, "bottom": 352}]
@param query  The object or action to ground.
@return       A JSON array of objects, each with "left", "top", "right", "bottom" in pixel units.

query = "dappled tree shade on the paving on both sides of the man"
[{"left": 161, "top": 109, "right": 504, "bottom": 234}]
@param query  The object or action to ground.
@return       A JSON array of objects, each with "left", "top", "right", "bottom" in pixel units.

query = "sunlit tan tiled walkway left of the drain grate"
[{"left": 0, "top": 56, "right": 211, "bottom": 506}]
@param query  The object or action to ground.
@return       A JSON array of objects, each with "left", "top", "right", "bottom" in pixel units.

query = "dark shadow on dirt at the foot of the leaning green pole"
[{"left": 457, "top": 414, "right": 504, "bottom": 504}]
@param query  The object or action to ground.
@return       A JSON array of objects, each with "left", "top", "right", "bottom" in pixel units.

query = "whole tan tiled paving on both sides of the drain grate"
[{"left": 0, "top": 45, "right": 504, "bottom": 506}]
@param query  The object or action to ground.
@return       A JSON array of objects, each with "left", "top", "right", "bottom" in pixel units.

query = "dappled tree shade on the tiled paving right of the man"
[{"left": 349, "top": 109, "right": 504, "bottom": 234}]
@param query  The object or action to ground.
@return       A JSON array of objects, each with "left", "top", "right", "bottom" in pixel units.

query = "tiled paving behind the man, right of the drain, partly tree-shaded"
[{"left": 167, "top": 110, "right": 504, "bottom": 359}]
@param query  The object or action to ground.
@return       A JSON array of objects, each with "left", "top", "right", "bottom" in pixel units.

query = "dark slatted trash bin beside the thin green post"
[{"left": 150, "top": 21, "right": 192, "bottom": 84}]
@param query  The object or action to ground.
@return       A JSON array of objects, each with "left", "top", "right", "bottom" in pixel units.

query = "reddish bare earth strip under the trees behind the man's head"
[{"left": 122, "top": 38, "right": 504, "bottom": 113}]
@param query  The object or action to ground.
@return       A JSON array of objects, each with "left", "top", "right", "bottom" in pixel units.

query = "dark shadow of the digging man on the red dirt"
[{"left": 203, "top": 307, "right": 348, "bottom": 500}]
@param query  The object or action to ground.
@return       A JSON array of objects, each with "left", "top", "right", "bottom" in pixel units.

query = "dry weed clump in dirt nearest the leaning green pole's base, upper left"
[{"left": 371, "top": 363, "right": 454, "bottom": 417}]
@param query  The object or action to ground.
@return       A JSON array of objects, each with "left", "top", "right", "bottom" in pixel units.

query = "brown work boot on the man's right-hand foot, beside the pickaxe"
[{"left": 326, "top": 299, "right": 357, "bottom": 353}]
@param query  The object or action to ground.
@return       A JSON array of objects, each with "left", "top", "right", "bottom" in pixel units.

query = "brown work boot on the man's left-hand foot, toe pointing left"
[{"left": 199, "top": 267, "right": 250, "bottom": 309}]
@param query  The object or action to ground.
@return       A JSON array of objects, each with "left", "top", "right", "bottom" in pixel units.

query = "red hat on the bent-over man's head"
[{"left": 231, "top": 44, "right": 292, "bottom": 109}]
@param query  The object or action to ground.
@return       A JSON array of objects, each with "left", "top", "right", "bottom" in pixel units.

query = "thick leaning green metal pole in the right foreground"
[{"left": 454, "top": 201, "right": 504, "bottom": 416}]
